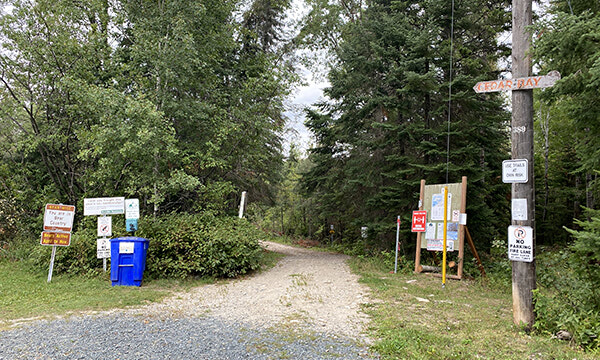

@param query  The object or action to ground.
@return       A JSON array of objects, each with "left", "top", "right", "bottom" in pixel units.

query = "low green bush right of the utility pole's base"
[{"left": 535, "top": 209, "right": 600, "bottom": 351}]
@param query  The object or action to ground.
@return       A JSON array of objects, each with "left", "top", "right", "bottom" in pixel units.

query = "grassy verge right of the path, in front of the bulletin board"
[{"left": 351, "top": 258, "right": 597, "bottom": 360}]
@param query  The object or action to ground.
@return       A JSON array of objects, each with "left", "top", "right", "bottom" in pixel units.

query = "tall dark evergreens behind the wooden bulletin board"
[{"left": 304, "top": 0, "right": 510, "bottom": 249}]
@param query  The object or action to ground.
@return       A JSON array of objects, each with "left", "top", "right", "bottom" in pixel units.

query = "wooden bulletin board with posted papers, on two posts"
[{"left": 415, "top": 176, "right": 467, "bottom": 279}]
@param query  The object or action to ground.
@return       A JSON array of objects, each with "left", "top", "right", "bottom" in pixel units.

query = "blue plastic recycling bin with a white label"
[{"left": 110, "top": 236, "right": 149, "bottom": 286}]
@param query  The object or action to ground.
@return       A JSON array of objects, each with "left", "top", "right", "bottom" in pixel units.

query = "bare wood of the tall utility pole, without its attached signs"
[{"left": 511, "top": 0, "right": 536, "bottom": 328}]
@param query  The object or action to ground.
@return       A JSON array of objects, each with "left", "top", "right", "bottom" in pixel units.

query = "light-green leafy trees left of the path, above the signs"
[{"left": 0, "top": 0, "right": 295, "bottom": 228}]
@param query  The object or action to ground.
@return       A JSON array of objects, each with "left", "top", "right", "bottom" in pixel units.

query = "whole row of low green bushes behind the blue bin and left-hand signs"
[{"left": 31, "top": 213, "right": 263, "bottom": 278}]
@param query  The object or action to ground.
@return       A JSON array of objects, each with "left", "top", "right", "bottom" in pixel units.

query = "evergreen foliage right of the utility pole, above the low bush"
[{"left": 534, "top": 0, "right": 600, "bottom": 244}]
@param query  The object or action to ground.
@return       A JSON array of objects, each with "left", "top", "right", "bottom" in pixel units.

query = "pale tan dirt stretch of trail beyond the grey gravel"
[{"left": 131, "top": 242, "right": 369, "bottom": 342}]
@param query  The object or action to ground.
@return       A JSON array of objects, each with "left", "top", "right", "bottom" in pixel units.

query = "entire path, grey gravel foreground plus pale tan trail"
[{"left": 0, "top": 242, "right": 376, "bottom": 359}]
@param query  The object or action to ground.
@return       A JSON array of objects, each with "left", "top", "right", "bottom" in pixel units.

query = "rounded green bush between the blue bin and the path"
[{"left": 138, "top": 213, "right": 263, "bottom": 278}]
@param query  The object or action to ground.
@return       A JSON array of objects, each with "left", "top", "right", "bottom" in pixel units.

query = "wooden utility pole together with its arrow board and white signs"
[{"left": 473, "top": 0, "right": 560, "bottom": 329}]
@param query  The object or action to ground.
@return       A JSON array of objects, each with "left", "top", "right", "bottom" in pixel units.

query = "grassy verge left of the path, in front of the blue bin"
[{"left": 0, "top": 252, "right": 283, "bottom": 330}]
